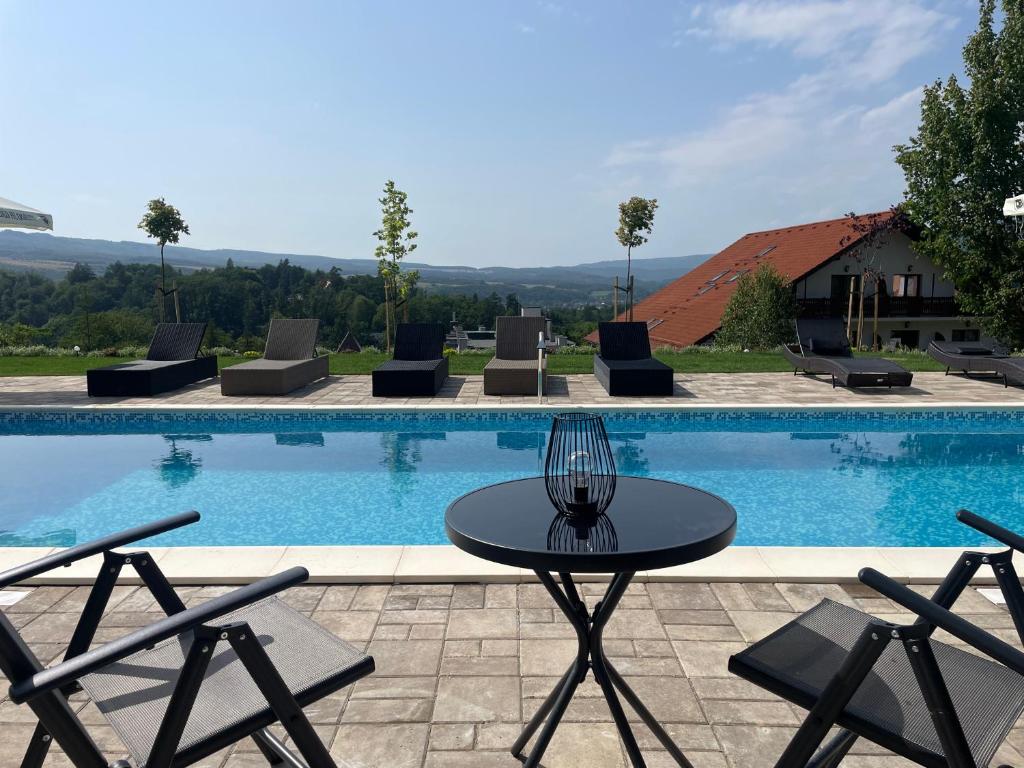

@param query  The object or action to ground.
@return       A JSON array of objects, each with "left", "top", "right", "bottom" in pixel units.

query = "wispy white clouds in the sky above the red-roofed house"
[{"left": 605, "top": 0, "right": 951, "bottom": 243}]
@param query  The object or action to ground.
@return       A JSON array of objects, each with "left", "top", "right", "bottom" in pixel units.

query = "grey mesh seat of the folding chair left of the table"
[{"left": 80, "top": 597, "right": 372, "bottom": 768}]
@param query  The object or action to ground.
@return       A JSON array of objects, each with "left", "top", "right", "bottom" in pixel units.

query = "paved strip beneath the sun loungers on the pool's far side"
[{"left": 0, "top": 373, "right": 1024, "bottom": 409}]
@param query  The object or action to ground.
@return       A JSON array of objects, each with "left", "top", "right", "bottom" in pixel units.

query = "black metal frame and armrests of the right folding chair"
[{"left": 744, "top": 510, "right": 1024, "bottom": 768}]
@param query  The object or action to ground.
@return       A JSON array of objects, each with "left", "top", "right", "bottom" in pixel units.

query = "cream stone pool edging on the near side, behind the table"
[{"left": 0, "top": 545, "right": 1000, "bottom": 586}]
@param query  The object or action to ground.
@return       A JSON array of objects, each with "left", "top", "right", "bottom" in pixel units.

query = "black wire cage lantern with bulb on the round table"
[{"left": 544, "top": 413, "right": 615, "bottom": 517}]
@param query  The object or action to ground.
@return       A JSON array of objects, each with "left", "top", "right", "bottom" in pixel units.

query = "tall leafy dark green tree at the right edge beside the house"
[{"left": 895, "top": 0, "right": 1024, "bottom": 346}]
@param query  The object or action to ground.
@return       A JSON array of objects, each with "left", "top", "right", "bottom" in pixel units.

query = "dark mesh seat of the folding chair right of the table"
[{"left": 729, "top": 600, "right": 1024, "bottom": 766}]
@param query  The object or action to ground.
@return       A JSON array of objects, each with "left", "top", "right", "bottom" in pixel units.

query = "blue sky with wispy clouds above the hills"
[{"left": 0, "top": 0, "right": 977, "bottom": 266}]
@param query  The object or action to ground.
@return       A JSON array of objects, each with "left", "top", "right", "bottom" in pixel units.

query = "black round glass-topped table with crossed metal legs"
[{"left": 444, "top": 477, "right": 736, "bottom": 768}]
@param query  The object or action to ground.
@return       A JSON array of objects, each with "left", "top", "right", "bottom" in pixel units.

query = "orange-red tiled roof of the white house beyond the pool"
[{"left": 587, "top": 213, "right": 886, "bottom": 347}]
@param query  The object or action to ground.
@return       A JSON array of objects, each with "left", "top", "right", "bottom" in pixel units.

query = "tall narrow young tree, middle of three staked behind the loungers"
[{"left": 374, "top": 179, "right": 420, "bottom": 352}]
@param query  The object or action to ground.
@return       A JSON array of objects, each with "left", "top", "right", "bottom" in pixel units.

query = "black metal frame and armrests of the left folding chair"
[{"left": 0, "top": 512, "right": 356, "bottom": 768}]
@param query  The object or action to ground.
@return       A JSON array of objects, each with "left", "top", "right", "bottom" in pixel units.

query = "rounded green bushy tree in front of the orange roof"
[{"left": 715, "top": 264, "right": 797, "bottom": 349}]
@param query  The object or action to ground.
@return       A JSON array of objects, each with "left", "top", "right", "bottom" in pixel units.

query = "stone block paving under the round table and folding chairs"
[{"left": 0, "top": 583, "right": 1024, "bottom": 768}]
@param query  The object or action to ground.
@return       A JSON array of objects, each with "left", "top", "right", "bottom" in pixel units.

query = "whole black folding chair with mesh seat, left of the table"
[{"left": 0, "top": 512, "right": 374, "bottom": 768}]
